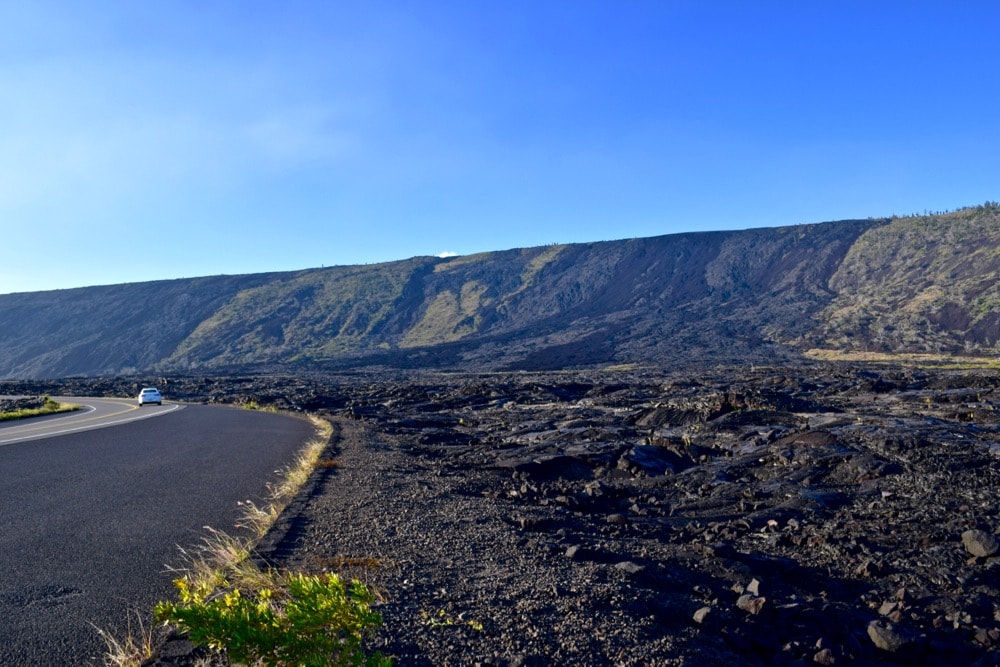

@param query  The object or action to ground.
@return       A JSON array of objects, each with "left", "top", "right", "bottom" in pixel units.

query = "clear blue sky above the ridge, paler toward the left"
[{"left": 0, "top": 0, "right": 1000, "bottom": 293}]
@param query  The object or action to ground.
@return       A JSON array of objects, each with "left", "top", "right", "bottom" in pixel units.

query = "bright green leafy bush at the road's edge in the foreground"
[{"left": 154, "top": 574, "right": 391, "bottom": 667}]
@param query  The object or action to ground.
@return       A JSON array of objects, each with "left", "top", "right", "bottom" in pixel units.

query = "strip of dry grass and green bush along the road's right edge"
[{"left": 98, "top": 417, "right": 391, "bottom": 667}]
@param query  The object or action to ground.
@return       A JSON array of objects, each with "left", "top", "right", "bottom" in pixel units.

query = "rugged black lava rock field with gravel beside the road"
[{"left": 0, "top": 366, "right": 1000, "bottom": 665}]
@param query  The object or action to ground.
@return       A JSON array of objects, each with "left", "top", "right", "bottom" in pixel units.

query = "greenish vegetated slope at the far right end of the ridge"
[{"left": 816, "top": 204, "right": 1000, "bottom": 353}]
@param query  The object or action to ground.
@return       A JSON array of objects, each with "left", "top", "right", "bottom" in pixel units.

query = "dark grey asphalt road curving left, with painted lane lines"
[{"left": 0, "top": 399, "right": 314, "bottom": 666}]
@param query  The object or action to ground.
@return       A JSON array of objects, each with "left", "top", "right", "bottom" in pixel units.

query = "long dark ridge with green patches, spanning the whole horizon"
[{"left": 0, "top": 204, "right": 1000, "bottom": 378}]
